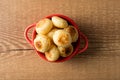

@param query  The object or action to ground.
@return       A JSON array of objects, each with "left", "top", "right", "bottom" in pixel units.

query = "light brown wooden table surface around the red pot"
[{"left": 0, "top": 0, "right": 120, "bottom": 80}]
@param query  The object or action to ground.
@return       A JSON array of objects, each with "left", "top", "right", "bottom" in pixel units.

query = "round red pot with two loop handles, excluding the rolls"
[{"left": 24, "top": 14, "right": 88, "bottom": 62}]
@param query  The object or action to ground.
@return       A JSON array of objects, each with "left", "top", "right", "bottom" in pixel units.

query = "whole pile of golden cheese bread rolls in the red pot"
[{"left": 34, "top": 16, "right": 78, "bottom": 61}]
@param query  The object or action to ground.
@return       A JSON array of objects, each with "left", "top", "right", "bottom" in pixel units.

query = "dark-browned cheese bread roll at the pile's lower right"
[{"left": 58, "top": 45, "right": 73, "bottom": 57}]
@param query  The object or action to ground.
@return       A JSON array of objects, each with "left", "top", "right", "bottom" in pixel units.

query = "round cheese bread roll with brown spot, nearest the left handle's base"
[{"left": 34, "top": 34, "right": 52, "bottom": 53}]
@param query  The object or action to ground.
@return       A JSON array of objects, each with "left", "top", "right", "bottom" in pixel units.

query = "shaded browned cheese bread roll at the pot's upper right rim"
[{"left": 64, "top": 25, "right": 78, "bottom": 42}]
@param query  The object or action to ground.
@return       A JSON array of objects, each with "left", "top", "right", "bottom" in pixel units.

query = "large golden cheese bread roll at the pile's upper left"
[{"left": 36, "top": 18, "right": 53, "bottom": 34}]
